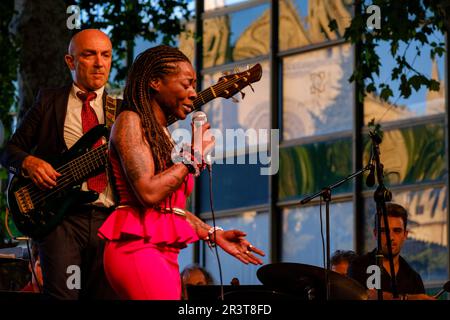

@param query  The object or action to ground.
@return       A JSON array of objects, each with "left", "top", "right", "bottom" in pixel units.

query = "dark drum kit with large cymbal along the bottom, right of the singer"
[{"left": 187, "top": 263, "right": 368, "bottom": 302}]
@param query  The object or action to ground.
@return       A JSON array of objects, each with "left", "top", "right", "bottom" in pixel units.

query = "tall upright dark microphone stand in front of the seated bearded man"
[{"left": 369, "top": 131, "right": 398, "bottom": 300}]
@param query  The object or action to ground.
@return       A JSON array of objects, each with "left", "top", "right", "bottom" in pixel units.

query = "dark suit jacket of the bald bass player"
[{"left": 1, "top": 84, "right": 121, "bottom": 174}]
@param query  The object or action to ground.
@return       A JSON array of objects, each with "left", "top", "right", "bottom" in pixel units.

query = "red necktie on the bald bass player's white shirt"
[{"left": 77, "top": 91, "right": 107, "bottom": 193}]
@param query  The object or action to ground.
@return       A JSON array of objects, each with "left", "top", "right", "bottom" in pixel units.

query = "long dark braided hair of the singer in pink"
[{"left": 124, "top": 45, "right": 190, "bottom": 173}]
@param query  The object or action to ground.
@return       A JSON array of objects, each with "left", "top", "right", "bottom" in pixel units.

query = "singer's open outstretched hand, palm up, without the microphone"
[{"left": 212, "top": 230, "right": 265, "bottom": 265}]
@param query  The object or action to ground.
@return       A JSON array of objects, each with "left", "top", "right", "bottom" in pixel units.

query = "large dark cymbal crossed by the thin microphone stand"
[{"left": 256, "top": 262, "right": 368, "bottom": 300}]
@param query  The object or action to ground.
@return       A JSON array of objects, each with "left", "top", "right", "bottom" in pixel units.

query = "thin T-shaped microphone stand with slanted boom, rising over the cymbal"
[{"left": 300, "top": 161, "right": 372, "bottom": 301}]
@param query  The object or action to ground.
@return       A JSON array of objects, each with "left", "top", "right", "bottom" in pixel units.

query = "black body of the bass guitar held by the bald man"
[{"left": 7, "top": 125, "right": 107, "bottom": 238}]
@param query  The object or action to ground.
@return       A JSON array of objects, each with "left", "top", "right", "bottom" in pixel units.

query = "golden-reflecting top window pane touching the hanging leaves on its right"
[{"left": 279, "top": 0, "right": 352, "bottom": 50}]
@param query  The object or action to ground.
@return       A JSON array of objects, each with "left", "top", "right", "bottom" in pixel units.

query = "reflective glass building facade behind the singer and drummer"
[{"left": 179, "top": 0, "right": 449, "bottom": 289}]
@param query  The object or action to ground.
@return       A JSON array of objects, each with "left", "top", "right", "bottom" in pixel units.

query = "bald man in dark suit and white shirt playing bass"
[{"left": 1, "top": 29, "right": 120, "bottom": 299}]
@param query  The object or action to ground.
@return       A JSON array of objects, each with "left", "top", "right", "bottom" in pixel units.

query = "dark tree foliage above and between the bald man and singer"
[{"left": 76, "top": 0, "right": 191, "bottom": 82}]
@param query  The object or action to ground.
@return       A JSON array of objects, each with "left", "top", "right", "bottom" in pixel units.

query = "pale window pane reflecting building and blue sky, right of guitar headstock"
[{"left": 283, "top": 44, "right": 354, "bottom": 140}]
